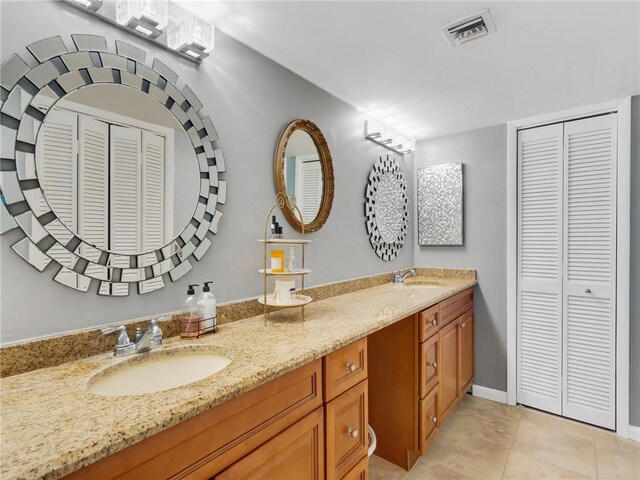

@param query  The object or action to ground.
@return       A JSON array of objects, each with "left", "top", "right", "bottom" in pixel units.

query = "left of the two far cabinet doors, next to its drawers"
[{"left": 438, "top": 321, "right": 460, "bottom": 423}]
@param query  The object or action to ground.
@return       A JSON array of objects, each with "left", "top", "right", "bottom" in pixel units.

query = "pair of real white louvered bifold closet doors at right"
[{"left": 517, "top": 114, "right": 617, "bottom": 428}]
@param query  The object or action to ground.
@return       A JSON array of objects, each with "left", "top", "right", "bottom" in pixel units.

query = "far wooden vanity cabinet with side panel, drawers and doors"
[{"left": 367, "top": 288, "right": 473, "bottom": 470}]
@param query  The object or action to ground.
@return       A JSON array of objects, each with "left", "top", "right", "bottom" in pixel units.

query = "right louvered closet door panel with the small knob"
[{"left": 563, "top": 114, "right": 617, "bottom": 429}]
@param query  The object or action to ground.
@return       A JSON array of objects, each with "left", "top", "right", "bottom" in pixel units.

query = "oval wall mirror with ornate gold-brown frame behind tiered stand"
[{"left": 274, "top": 119, "right": 334, "bottom": 232}]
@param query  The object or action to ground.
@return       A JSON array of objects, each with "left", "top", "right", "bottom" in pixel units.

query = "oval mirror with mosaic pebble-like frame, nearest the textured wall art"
[{"left": 365, "top": 155, "right": 409, "bottom": 261}]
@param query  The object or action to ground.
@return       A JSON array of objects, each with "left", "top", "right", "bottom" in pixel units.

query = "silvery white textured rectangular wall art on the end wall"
[{"left": 418, "top": 163, "right": 464, "bottom": 246}]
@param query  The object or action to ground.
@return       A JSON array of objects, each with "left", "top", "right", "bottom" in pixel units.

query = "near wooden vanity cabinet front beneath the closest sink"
[{"left": 65, "top": 338, "right": 368, "bottom": 480}]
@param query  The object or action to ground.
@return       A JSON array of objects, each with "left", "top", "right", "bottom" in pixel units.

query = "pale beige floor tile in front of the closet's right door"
[{"left": 512, "top": 421, "right": 597, "bottom": 478}]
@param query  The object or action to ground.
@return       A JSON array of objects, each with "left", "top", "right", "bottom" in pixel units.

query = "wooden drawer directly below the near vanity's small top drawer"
[{"left": 325, "top": 380, "right": 369, "bottom": 480}]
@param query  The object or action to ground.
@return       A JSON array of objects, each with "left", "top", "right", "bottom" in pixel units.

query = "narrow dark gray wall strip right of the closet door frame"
[{"left": 629, "top": 96, "right": 640, "bottom": 425}]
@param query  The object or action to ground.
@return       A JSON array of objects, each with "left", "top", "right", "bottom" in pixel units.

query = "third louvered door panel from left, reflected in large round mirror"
[{"left": 109, "top": 125, "right": 142, "bottom": 256}]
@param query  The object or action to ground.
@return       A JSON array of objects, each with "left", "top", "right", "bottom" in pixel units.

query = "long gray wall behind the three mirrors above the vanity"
[{"left": 0, "top": 1, "right": 413, "bottom": 343}]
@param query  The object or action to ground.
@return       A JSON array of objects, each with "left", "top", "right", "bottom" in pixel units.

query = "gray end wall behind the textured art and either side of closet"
[{"left": 414, "top": 106, "right": 640, "bottom": 425}]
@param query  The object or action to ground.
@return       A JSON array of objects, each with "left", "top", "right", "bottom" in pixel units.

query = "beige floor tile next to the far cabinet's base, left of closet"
[{"left": 447, "top": 408, "right": 519, "bottom": 448}]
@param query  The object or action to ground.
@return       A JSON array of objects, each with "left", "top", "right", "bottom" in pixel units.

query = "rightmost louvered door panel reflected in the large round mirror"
[{"left": 141, "top": 131, "right": 165, "bottom": 252}]
